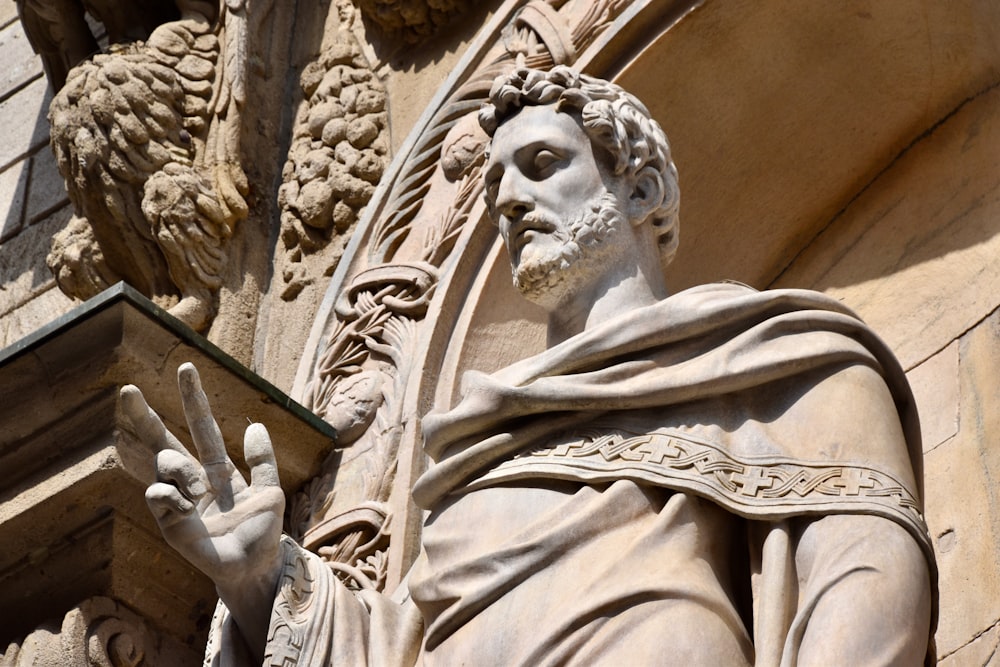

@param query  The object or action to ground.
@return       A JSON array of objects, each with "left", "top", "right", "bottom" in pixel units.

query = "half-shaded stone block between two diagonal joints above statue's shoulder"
[{"left": 778, "top": 88, "right": 1000, "bottom": 368}]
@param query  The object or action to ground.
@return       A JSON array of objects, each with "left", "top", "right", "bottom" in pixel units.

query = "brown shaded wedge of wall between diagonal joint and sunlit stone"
[{"left": 776, "top": 84, "right": 1000, "bottom": 290}]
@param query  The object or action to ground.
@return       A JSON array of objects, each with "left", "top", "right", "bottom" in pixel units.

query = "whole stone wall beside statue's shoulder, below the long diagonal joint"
[{"left": 777, "top": 83, "right": 1000, "bottom": 666}]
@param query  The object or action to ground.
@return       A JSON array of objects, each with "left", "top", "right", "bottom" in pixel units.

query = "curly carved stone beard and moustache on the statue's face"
[{"left": 511, "top": 192, "right": 628, "bottom": 301}]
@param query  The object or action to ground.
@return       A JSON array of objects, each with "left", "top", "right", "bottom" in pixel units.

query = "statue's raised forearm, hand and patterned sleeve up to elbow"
[{"left": 121, "top": 364, "right": 422, "bottom": 667}]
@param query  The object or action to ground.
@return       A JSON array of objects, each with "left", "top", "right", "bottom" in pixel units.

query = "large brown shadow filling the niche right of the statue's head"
[{"left": 616, "top": 0, "right": 1000, "bottom": 298}]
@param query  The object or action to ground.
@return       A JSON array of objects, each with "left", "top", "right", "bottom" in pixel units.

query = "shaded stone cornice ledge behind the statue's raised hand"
[{"left": 0, "top": 284, "right": 335, "bottom": 665}]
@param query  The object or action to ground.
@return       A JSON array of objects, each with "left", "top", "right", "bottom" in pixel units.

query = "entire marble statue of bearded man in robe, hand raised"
[{"left": 123, "top": 67, "right": 934, "bottom": 666}]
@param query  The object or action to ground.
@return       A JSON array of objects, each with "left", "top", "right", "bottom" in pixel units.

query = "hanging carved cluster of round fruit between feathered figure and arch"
[{"left": 278, "top": 6, "right": 389, "bottom": 301}]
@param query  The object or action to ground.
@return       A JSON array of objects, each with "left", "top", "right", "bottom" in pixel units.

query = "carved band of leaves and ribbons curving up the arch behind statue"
[{"left": 288, "top": 0, "right": 628, "bottom": 589}]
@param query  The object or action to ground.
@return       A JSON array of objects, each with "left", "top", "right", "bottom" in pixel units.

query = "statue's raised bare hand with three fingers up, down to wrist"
[{"left": 121, "top": 363, "right": 285, "bottom": 644}]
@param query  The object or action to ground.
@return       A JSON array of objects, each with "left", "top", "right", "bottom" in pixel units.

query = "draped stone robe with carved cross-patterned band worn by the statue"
[{"left": 209, "top": 283, "right": 934, "bottom": 665}]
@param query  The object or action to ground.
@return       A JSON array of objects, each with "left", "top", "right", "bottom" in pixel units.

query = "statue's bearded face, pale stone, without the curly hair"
[{"left": 486, "top": 106, "right": 626, "bottom": 308}]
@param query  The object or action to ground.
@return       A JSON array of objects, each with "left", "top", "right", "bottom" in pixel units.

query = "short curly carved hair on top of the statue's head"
[{"left": 479, "top": 65, "right": 680, "bottom": 267}]
